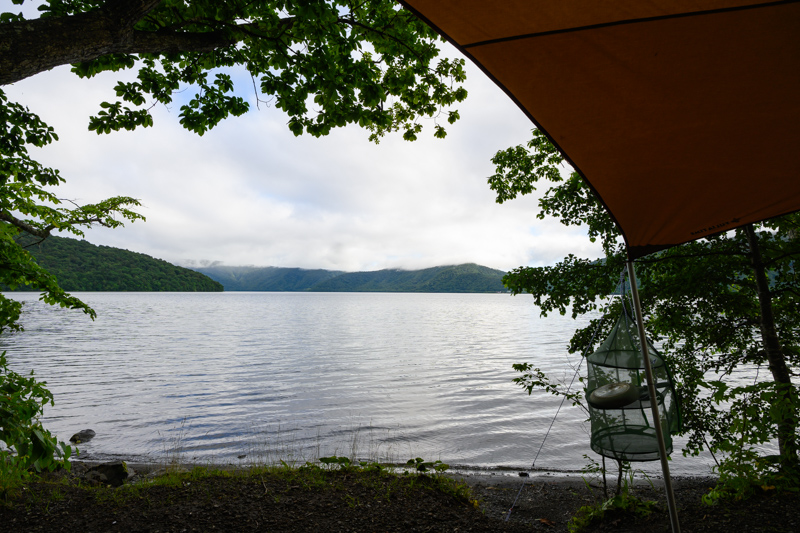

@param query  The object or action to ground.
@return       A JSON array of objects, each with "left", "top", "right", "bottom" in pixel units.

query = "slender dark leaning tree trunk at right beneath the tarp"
[{"left": 744, "top": 224, "right": 798, "bottom": 470}]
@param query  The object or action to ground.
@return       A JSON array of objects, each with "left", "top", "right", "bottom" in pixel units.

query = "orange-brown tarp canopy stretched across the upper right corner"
[{"left": 402, "top": 0, "right": 800, "bottom": 258}]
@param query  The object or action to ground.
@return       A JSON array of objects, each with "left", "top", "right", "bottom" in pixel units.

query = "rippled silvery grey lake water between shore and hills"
[{"left": 0, "top": 292, "right": 711, "bottom": 475}]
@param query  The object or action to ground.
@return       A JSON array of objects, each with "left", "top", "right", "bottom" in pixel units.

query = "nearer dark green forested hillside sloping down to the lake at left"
[{"left": 8, "top": 237, "right": 223, "bottom": 292}]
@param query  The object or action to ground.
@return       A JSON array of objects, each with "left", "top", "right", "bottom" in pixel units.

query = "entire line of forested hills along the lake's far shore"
[{"left": 0, "top": 237, "right": 506, "bottom": 292}]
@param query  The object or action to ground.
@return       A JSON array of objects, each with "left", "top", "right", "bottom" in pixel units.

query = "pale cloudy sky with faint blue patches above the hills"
[{"left": 3, "top": 37, "right": 600, "bottom": 271}]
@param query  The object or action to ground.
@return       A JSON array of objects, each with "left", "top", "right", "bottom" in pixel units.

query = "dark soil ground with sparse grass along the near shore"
[{"left": 0, "top": 462, "right": 800, "bottom": 533}]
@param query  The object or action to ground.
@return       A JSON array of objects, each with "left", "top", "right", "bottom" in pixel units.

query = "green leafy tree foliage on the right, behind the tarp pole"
[{"left": 489, "top": 131, "right": 800, "bottom": 486}]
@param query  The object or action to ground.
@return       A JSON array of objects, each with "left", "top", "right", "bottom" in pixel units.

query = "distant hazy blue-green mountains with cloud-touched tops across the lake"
[{"left": 197, "top": 264, "right": 505, "bottom": 292}]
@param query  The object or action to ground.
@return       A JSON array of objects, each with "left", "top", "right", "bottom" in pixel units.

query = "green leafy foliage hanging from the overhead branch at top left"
[{"left": 18, "top": 0, "right": 467, "bottom": 140}]
